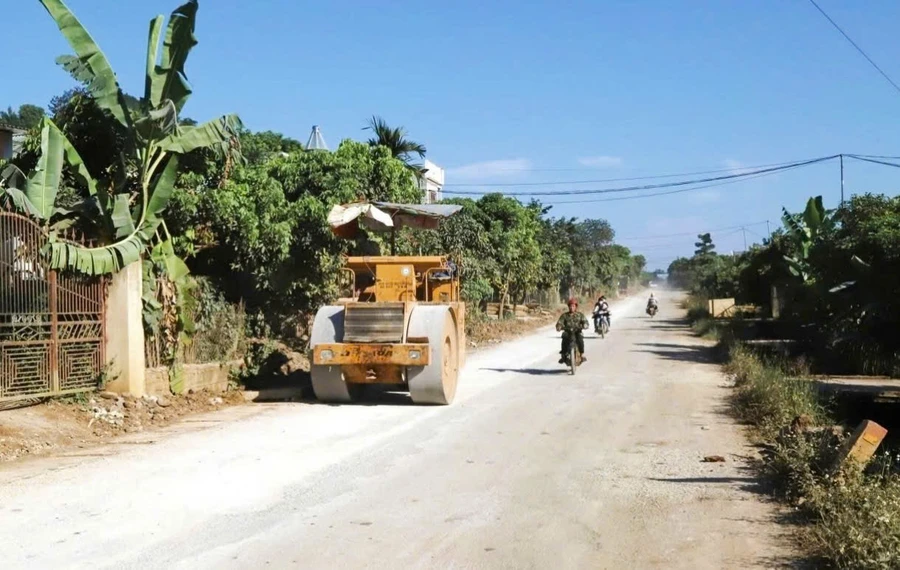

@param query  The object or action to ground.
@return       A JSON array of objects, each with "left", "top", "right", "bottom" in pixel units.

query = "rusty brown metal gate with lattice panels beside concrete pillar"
[{"left": 0, "top": 210, "right": 106, "bottom": 402}]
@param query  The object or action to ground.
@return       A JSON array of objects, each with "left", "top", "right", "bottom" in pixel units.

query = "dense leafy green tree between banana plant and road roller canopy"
[{"left": 168, "top": 140, "right": 419, "bottom": 330}]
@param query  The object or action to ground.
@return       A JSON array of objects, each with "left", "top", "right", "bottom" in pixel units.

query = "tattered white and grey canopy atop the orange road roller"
[{"left": 328, "top": 202, "right": 462, "bottom": 239}]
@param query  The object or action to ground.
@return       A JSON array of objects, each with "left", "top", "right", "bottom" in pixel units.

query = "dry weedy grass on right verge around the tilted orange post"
[{"left": 725, "top": 344, "right": 900, "bottom": 570}]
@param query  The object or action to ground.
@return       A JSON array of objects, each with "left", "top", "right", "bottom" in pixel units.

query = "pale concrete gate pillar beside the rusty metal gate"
[{"left": 106, "top": 261, "right": 146, "bottom": 396}]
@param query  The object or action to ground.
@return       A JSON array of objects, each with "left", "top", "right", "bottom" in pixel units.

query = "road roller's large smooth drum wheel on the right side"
[{"left": 406, "top": 305, "right": 459, "bottom": 405}]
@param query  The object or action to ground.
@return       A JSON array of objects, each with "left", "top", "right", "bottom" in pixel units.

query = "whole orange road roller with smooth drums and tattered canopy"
[{"left": 310, "top": 203, "right": 466, "bottom": 405}]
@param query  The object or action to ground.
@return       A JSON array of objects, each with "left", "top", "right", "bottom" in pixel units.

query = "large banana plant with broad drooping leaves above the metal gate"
[{"left": 6, "top": 0, "right": 241, "bottom": 275}]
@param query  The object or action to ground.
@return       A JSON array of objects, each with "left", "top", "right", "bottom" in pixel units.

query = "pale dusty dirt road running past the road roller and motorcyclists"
[{"left": 0, "top": 292, "right": 786, "bottom": 570}]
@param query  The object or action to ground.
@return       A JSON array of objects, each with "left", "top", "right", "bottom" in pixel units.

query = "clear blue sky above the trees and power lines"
[{"left": 0, "top": 0, "right": 900, "bottom": 267}]
